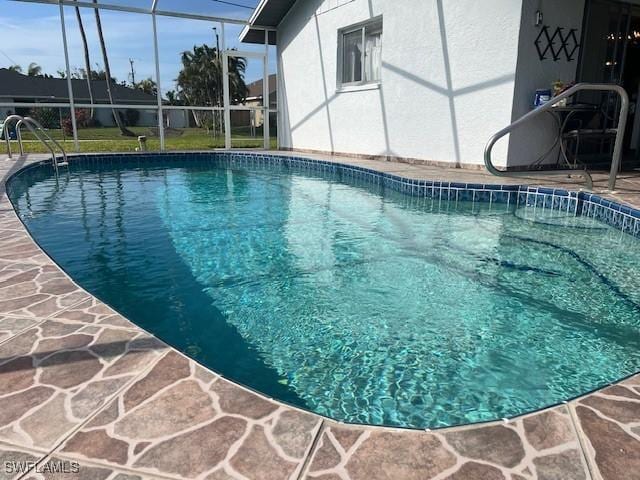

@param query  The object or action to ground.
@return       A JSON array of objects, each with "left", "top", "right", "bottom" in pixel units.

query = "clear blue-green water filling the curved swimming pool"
[{"left": 10, "top": 160, "right": 640, "bottom": 428}]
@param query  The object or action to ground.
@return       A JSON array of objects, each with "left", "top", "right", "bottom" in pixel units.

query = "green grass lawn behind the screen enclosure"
[{"left": 11, "top": 127, "right": 277, "bottom": 153}]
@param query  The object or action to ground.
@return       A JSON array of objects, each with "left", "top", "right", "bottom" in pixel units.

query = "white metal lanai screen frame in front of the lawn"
[{"left": 0, "top": 0, "right": 280, "bottom": 152}]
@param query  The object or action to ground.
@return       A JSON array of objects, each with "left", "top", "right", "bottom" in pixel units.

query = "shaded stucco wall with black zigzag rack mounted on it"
[{"left": 509, "top": 0, "right": 585, "bottom": 166}]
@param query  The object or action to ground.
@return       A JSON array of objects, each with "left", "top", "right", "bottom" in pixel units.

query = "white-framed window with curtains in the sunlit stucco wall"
[{"left": 338, "top": 18, "right": 382, "bottom": 87}]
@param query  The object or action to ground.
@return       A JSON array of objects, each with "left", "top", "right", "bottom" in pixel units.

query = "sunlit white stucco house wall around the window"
[{"left": 278, "top": 0, "right": 524, "bottom": 164}]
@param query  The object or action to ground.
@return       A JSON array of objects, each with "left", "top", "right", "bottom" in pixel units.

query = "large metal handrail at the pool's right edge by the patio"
[{"left": 484, "top": 83, "right": 629, "bottom": 190}]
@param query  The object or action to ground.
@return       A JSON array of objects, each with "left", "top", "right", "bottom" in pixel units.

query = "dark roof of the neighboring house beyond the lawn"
[{"left": 0, "top": 68, "right": 157, "bottom": 105}]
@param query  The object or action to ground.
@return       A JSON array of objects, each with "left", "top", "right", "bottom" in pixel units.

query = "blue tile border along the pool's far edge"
[{"left": 6, "top": 151, "right": 640, "bottom": 237}]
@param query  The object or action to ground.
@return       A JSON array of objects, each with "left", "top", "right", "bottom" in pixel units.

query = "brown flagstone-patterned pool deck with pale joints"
[{"left": 0, "top": 152, "right": 640, "bottom": 480}]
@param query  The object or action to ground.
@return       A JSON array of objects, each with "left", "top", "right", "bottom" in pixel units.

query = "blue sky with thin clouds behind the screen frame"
[{"left": 0, "top": 0, "right": 275, "bottom": 97}]
